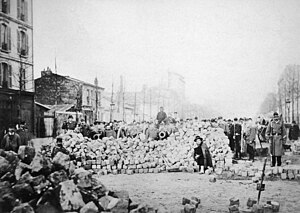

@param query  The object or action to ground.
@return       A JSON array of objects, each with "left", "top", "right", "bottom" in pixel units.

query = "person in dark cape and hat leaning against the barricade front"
[{"left": 194, "top": 135, "right": 213, "bottom": 174}]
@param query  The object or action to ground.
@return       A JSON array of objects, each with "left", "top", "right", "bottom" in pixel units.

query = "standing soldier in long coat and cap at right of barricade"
[{"left": 266, "top": 112, "right": 286, "bottom": 167}]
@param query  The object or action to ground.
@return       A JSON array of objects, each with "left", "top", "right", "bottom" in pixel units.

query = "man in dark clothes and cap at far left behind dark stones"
[{"left": 0, "top": 125, "right": 21, "bottom": 153}]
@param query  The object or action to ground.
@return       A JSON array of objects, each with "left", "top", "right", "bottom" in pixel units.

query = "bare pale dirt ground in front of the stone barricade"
[{"left": 100, "top": 172, "right": 300, "bottom": 213}]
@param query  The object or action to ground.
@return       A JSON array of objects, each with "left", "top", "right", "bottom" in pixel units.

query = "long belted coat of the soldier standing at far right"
[{"left": 266, "top": 121, "right": 286, "bottom": 156}]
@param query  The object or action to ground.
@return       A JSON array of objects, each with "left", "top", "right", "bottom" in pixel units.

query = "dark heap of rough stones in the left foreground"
[{"left": 0, "top": 146, "right": 162, "bottom": 213}]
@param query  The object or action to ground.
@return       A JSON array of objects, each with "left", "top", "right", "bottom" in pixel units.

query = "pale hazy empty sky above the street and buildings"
[{"left": 33, "top": 0, "right": 300, "bottom": 117}]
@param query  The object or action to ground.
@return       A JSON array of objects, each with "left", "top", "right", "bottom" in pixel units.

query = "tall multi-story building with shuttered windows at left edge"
[{"left": 0, "top": 0, "right": 34, "bottom": 136}]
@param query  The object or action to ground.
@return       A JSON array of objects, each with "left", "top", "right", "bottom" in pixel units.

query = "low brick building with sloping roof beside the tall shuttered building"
[{"left": 35, "top": 68, "right": 104, "bottom": 123}]
